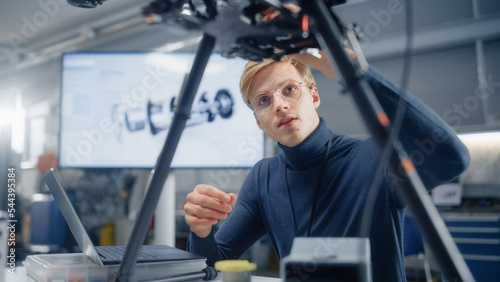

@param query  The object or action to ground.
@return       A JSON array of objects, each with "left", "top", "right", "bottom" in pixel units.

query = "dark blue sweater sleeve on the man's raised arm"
[{"left": 367, "top": 67, "right": 470, "bottom": 190}]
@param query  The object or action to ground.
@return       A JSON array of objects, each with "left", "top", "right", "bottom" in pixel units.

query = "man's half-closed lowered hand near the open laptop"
[{"left": 182, "top": 184, "right": 236, "bottom": 238}]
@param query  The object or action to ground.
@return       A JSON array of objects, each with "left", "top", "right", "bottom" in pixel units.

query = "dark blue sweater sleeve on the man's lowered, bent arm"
[{"left": 187, "top": 164, "right": 265, "bottom": 266}]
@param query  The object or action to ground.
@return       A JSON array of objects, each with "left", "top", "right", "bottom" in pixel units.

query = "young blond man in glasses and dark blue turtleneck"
[{"left": 184, "top": 52, "right": 469, "bottom": 281}]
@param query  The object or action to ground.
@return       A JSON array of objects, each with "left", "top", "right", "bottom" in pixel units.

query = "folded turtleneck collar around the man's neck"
[{"left": 278, "top": 117, "right": 334, "bottom": 169}]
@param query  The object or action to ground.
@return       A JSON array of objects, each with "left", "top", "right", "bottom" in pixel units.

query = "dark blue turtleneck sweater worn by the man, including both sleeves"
[{"left": 188, "top": 66, "right": 469, "bottom": 282}]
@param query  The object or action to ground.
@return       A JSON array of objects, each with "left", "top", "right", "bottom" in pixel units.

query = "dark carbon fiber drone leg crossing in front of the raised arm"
[{"left": 302, "top": 0, "right": 474, "bottom": 281}]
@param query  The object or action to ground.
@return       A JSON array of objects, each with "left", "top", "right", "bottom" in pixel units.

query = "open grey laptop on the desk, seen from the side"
[{"left": 43, "top": 169, "right": 206, "bottom": 270}]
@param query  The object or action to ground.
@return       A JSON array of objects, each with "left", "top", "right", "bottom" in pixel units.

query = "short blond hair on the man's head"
[{"left": 240, "top": 56, "right": 316, "bottom": 105}]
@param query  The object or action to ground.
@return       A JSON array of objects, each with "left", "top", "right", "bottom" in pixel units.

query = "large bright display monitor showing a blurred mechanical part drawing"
[{"left": 59, "top": 53, "right": 264, "bottom": 168}]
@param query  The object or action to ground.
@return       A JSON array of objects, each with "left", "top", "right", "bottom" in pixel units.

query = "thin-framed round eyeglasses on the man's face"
[{"left": 250, "top": 80, "right": 303, "bottom": 114}]
